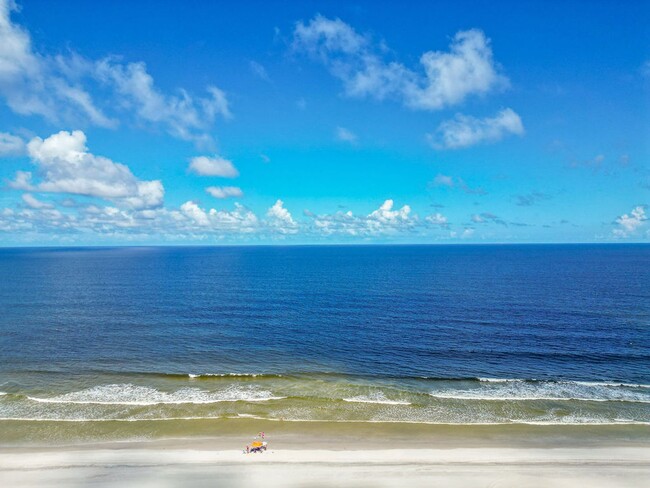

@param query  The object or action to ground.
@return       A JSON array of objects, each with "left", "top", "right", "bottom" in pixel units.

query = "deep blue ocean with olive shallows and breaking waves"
[{"left": 0, "top": 245, "right": 650, "bottom": 443}]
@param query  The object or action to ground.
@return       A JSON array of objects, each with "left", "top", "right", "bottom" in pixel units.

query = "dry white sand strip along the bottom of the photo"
[{"left": 0, "top": 440, "right": 650, "bottom": 488}]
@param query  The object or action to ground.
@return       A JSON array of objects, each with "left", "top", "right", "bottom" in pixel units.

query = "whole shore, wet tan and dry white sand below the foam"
[{"left": 0, "top": 406, "right": 650, "bottom": 488}]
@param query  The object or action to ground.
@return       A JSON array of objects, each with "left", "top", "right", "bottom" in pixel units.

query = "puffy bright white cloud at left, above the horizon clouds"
[{"left": 10, "top": 130, "right": 165, "bottom": 208}]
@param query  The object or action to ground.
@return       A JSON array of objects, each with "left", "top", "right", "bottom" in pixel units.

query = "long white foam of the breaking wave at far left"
[{"left": 27, "top": 384, "right": 285, "bottom": 406}]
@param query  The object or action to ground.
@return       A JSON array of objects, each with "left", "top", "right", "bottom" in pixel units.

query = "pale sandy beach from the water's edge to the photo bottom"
[{"left": 0, "top": 426, "right": 650, "bottom": 487}]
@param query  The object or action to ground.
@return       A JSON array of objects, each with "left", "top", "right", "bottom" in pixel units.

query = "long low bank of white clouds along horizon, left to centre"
[{"left": 0, "top": 194, "right": 464, "bottom": 242}]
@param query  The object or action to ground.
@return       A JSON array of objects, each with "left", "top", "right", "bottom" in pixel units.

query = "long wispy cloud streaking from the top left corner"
[{"left": 0, "top": 0, "right": 230, "bottom": 146}]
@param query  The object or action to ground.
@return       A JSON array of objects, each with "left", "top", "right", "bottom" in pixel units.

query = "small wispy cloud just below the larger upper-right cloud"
[{"left": 427, "top": 108, "right": 524, "bottom": 149}]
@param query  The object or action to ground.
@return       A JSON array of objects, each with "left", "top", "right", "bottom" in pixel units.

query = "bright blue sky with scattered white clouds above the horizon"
[{"left": 0, "top": 0, "right": 650, "bottom": 246}]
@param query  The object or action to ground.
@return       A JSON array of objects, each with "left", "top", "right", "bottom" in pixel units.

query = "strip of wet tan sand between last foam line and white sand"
[{"left": 0, "top": 418, "right": 650, "bottom": 452}]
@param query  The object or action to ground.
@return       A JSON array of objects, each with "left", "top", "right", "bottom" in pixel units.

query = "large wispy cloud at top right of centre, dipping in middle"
[{"left": 292, "top": 15, "right": 508, "bottom": 110}]
